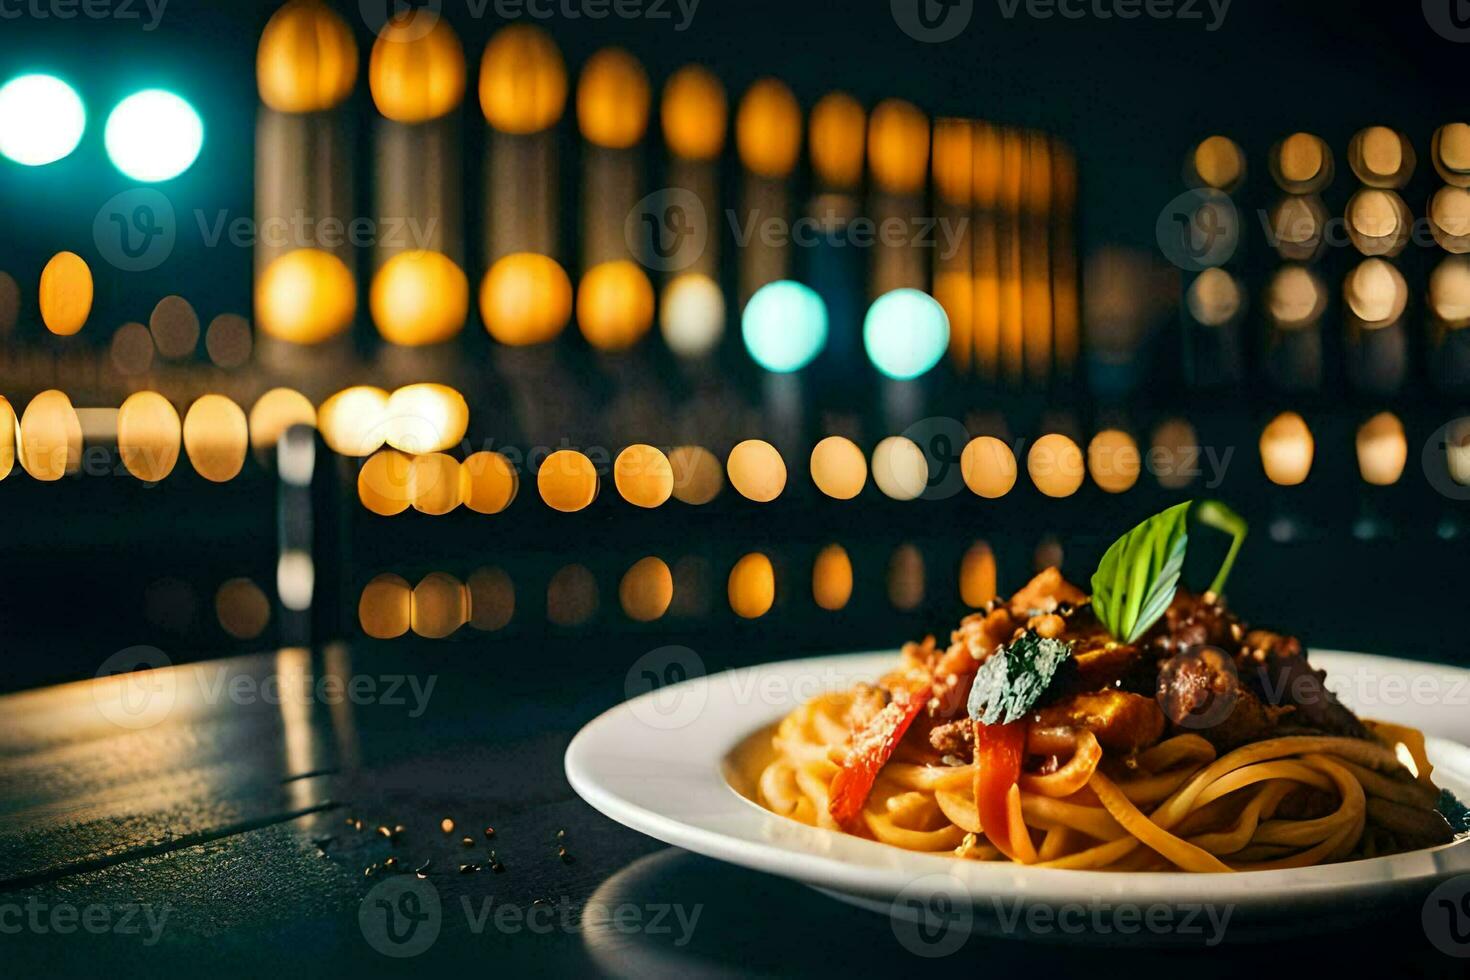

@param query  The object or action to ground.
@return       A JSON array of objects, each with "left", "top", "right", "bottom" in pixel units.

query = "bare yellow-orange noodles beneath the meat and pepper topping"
[{"left": 754, "top": 692, "right": 1435, "bottom": 873}]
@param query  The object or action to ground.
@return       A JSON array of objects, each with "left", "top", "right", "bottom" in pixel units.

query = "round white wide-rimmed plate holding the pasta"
[{"left": 566, "top": 648, "right": 1470, "bottom": 942}]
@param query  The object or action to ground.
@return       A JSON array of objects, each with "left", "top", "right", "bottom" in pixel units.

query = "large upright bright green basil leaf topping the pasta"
[{"left": 1092, "top": 501, "right": 1194, "bottom": 644}]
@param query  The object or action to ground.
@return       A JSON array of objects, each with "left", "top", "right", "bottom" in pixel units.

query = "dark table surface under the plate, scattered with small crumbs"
[{"left": 0, "top": 642, "right": 1470, "bottom": 977}]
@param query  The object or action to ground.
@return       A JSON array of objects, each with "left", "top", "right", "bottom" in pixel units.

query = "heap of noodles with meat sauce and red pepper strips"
[{"left": 753, "top": 569, "right": 1454, "bottom": 873}]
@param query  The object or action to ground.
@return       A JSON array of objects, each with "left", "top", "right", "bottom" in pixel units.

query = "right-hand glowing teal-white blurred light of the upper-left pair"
[{"left": 103, "top": 88, "right": 204, "bottom": 184}]
